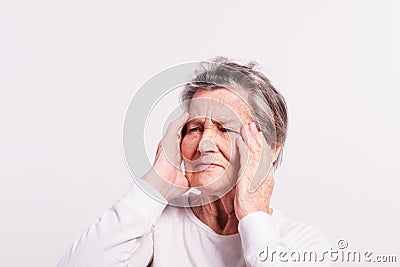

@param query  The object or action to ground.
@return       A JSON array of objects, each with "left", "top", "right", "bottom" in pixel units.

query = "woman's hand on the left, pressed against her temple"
[{"left": 142, "top": 112, "right": 189, "bottom": 201}]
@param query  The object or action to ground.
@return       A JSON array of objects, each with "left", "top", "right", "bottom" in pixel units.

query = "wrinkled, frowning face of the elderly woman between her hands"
[{"left": 181, "top": 88, "right": 252, "bottom": 194}]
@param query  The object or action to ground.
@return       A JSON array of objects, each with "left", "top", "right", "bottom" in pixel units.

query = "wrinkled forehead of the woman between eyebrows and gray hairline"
[{"left": 189, "top": 88, "right": 252, "bottom": 123}]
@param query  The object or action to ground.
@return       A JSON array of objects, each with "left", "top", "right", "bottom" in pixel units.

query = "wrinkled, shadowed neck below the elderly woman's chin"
[{"left": 191, "top": 188, "right": 239, "bottom": 235}]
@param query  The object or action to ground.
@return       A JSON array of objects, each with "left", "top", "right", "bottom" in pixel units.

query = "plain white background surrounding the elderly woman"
[{"left": 0, "top": 0, "right": 400, "bottom": 266}]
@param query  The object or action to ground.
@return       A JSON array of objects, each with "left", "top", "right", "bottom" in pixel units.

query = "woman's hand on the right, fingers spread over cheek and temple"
[{"left": 234, "top": 122, "right": 274, "bottom": 220}]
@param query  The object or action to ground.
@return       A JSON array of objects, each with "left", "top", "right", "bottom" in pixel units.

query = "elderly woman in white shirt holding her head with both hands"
[{"left": 59, "top": 58, "right": 329, "bottom": 267}]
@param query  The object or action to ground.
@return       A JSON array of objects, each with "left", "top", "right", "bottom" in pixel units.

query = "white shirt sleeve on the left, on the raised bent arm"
[{"left": 57, "top": 180, "right": 167, "bottom": 267}]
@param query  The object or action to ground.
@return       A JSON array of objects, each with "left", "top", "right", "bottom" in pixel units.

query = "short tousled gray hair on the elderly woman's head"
[{"left": 181, "top": 57, "right": 288, "bottom": 169}]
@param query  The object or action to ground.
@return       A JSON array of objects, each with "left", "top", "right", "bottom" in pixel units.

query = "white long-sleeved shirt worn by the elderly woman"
[{"left": 58, "top": 182, "right": 330, "bottom": 267}]
